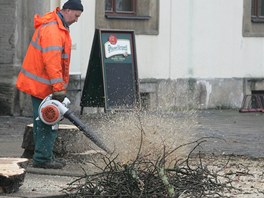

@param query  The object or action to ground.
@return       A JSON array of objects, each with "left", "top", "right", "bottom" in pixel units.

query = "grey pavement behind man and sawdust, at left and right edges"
[{"left": 0, "top": 110, "right": 264, "bottom": 157}]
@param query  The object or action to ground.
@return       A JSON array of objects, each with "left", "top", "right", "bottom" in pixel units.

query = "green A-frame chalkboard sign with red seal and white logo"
[{"left": 80, "top": 29, "right": 139, "bottom": 113}]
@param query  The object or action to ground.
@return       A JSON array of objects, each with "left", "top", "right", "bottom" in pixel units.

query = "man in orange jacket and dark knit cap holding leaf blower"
[{"left": 16, "top": 0, "right": 83, "bottom": 169}]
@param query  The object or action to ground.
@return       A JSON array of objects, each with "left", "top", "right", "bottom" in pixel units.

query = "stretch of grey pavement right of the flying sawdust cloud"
[{"left": 196, "top": 110, "right": 264, "bottom": 157}]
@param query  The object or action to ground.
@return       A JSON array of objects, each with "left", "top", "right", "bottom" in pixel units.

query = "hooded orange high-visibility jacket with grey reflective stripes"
[{"left": 16, "top": 8, "right": 71, "bottom": 99}]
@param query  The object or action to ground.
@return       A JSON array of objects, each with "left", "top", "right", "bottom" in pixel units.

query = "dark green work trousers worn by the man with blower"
[{"left": 32, "top": 96, "right": 58, "bottom": 164}]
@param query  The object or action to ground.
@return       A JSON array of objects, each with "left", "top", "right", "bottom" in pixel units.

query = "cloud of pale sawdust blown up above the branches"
[{"left": 92, "top": 110, "right": 198, "bottom": 162}]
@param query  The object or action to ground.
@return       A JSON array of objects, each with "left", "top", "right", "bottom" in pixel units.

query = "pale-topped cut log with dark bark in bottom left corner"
[{"left": 0, "top": 158, "right": 28, "bottom": 193}]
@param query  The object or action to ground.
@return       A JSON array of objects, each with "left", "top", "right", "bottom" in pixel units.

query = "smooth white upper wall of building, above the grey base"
[{"left": 58, "top": 0, "right": 264, "bottom": 79}]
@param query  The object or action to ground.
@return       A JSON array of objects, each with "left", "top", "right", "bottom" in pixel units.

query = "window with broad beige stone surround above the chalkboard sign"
[{"left": 95, "top": 0, "right": 159, "bottom": 35}]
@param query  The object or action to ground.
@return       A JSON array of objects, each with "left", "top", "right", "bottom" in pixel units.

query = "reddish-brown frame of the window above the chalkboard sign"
[{"left": 105, "top": 0, "right": 137, "bottom": 17}]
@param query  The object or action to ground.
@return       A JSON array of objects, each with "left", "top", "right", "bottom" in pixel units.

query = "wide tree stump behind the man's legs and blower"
[{"left": 22, "top": 124, "right": 95, "bottom": 156}]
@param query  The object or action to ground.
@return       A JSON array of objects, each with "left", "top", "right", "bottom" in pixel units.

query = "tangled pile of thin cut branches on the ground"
[{"left": 64, "top": 138, "right": 233, "bottom": 198}]
